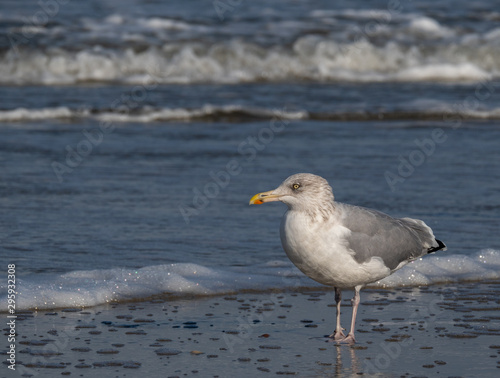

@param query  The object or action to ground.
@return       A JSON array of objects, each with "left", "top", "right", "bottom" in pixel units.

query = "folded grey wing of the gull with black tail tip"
[{"left": 337, "top": 203, "right": 446, "bottom": 270}]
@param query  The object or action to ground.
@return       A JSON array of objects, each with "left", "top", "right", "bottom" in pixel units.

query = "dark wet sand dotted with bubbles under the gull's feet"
[{"left": 0, "top": 282, "right": 500, "bottom": 378}]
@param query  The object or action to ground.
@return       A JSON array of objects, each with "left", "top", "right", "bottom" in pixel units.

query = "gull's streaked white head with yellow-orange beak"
[{"left": 250, "top": 173, "right": 333, "bottom": 211}]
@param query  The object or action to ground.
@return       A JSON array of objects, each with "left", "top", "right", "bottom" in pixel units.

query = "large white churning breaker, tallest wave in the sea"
[{"left": 0, "top": 35, "right": 500, "bottom": 85}]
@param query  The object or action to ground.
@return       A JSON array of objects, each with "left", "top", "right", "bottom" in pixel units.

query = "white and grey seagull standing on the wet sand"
[{"left": 250, "top": 173, "right": 446, "bottom": 344}]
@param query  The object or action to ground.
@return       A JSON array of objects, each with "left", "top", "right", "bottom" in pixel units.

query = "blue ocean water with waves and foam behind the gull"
[{"left": 0, "top": 0, "right": 500, "bottom": 310}]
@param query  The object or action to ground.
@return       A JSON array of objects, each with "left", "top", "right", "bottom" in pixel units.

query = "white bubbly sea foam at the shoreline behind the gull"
[{"left": 0, "top": 249, "right": 500, "bottom": 311}]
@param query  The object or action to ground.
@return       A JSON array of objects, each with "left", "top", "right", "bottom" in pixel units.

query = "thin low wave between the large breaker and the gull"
[{"left": 0, "top": 104, "right": 500, "bottom": 123}]
